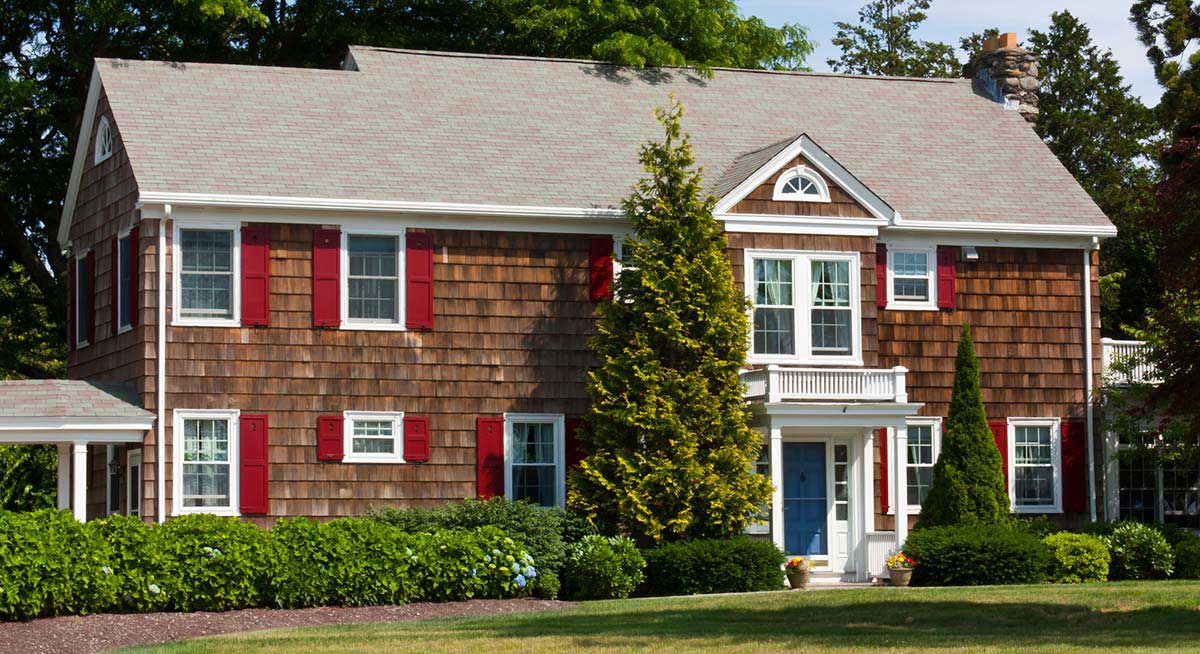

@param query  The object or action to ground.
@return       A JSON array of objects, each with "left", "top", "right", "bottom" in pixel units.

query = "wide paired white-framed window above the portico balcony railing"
[{"left": 746, "top": 251, "right": 862, "bottom": 364}]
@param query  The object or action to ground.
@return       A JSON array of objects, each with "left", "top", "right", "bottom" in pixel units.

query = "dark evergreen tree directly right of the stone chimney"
[{"left": 1028, "top": 11, "right": 1162, "bottom": 336}]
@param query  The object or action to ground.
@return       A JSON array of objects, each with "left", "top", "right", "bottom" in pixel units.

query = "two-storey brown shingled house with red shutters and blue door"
[{"left": 0, "top": 33, "right": 1152, "bottom": 577}]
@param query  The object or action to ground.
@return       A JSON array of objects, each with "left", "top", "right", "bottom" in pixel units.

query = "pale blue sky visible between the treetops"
[{"left": 737, "top": 0, "right": 1162, "bottom": 104}]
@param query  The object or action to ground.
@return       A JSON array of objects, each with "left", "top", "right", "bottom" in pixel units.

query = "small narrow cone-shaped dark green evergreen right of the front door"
[{"left": 917, "top": 325, "right": 1009, "bottom": 528}]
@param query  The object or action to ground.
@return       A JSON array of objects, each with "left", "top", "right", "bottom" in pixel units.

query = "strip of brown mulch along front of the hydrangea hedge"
[{"left": 0, "top": 599, "right": 572, "bottom": 654}]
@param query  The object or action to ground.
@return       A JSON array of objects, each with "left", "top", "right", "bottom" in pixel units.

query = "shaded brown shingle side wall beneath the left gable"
[{"left": 67, "top": 91, "right": 155, "bottom": 517}]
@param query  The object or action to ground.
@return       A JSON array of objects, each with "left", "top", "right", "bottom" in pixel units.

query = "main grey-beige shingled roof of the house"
[{"left": 82, "top": 47, "right": 1111, "bottom": 229}]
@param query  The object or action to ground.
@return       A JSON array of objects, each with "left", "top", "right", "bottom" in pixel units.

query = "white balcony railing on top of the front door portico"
[{"left": 742, "top": 365, "right": 908, "bottom": 402}]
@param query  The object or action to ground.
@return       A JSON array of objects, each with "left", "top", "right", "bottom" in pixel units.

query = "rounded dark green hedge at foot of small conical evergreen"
[{"left": 904, "top": 526, "right": 1051, "bottom": 586}]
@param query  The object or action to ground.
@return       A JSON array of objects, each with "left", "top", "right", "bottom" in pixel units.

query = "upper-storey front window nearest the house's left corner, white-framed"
[{"left": 174, "top": 224, "right": 241, "bottom": 325}]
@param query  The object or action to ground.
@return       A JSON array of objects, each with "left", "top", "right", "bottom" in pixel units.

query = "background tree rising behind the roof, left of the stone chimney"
[{"left": 828, "top": 0, "right": 961, "bottom": 77}]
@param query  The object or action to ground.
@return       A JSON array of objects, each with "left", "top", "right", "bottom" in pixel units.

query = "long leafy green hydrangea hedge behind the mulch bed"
[{"left": 0, "top": 510, "right": 538, "bottom": 620}]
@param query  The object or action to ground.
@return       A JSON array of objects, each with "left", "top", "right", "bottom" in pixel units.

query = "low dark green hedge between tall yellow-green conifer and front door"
[{"left": 637, "top": 536, "right": 784, "bottom": 595}]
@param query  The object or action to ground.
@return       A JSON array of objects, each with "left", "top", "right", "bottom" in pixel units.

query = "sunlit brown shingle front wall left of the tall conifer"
[{"left": 167, "top": 224, "right": 594, "bottom": 516}]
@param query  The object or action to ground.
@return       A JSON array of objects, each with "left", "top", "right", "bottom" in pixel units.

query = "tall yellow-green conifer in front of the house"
[{"left": 568, "top": 102, "right": 770, "bottom": 545}]
